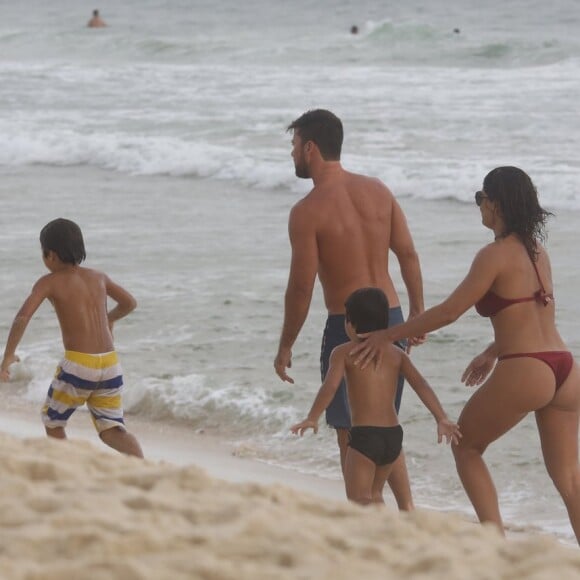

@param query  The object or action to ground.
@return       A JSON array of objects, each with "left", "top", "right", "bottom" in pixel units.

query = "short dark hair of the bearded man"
[{"left": 287, "top": 109, "right": 344, "bottom": 161}]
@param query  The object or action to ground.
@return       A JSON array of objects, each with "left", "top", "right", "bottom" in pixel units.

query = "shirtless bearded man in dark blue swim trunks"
[{"left": 274, "top": 109, "right": 424, "bottom": 510}]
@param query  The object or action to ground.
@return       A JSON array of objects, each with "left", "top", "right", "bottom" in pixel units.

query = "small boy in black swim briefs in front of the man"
[{"left": 291, "top": 288, "right": 461, "bottom": 504}]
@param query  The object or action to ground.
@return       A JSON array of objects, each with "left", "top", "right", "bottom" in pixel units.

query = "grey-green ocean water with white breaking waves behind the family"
[{"left": 0, "top": 0, "right": 580, "bottom": 541}]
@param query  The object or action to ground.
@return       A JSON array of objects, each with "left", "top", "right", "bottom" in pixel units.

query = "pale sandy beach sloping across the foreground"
[{"left": 0, "top": 409, "right": 580, "bottom": 580}]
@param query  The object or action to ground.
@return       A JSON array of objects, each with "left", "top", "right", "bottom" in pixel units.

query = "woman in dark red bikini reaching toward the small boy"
[{"left": 352, "top": 167, "right": 580, "bottom": 543}]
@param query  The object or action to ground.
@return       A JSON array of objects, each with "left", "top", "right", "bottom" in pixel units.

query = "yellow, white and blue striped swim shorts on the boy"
[{"left": 41, "top": 350, "right": 125, "bottom": 433}]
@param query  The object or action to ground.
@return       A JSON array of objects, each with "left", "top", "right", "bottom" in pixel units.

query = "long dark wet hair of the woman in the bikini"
[{"left": 483, "top": 166, "right": 554, "bottom": 261}]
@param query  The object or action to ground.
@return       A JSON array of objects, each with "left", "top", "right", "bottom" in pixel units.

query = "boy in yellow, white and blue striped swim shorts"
[{"left": 0, "top": 218, "right": 143, "bottom": 457}]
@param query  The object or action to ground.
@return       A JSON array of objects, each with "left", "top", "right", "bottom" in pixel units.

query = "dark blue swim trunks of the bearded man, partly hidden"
[{"left": 320, "top": 306, "right": 407, "bottom": 429}]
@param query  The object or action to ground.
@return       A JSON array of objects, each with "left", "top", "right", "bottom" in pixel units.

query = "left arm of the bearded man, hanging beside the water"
[{"left": 274, "top": 204, "right": 318, "bottom": 383}]
